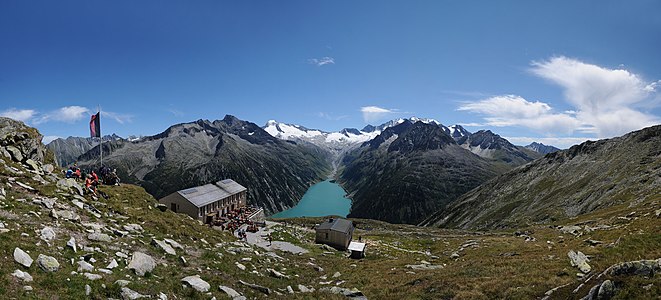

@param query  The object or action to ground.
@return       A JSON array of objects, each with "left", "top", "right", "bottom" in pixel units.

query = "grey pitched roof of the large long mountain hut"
[{"left": 177, "top": 179, "right": 246, "bottom": 207}]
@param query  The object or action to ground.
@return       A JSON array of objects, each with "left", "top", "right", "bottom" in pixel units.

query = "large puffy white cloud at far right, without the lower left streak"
[{"left": 531, "top": 57, "right": 660, "bottom": 137}]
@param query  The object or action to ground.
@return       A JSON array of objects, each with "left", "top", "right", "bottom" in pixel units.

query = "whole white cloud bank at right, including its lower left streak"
[{"left": 458, "top": 57, "right": 661, "bottom": 138}]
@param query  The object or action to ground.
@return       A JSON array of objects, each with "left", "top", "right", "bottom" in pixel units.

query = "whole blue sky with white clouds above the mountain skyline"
[{"left": 0, "top": 0, "right": 661, "bottom": 147}]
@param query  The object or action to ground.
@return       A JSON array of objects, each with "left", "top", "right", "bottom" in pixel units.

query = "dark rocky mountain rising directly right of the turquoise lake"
[{"left": 340, "top": 120, "right": 499, "bottom": 223}]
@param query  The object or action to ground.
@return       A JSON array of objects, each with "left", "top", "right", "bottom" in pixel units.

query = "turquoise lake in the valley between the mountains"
[{"left": 271, "top": 180, "right": 351, "bottom": 218}]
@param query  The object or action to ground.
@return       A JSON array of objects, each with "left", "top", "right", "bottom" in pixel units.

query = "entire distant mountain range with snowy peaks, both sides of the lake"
[{"left": 48, "top": 116, "right": 556, "bottom": 224}]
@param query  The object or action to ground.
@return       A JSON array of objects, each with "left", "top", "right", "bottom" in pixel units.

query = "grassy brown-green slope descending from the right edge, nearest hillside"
[{"left": 422, "top": 126, "right": 661, "bottom": 229}]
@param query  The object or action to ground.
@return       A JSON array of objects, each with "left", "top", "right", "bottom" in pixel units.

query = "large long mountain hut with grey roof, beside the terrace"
[{"left": 158, "top": 179, "right": 248, "bottom": 221}]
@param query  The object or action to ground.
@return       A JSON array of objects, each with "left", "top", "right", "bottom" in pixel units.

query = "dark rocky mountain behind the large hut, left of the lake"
[{"left": 79, "top": 116, "right": 330, "bottom": 212}]
